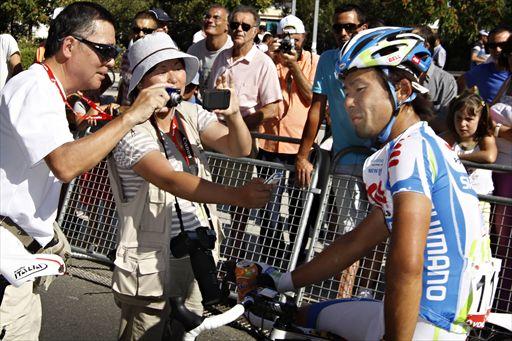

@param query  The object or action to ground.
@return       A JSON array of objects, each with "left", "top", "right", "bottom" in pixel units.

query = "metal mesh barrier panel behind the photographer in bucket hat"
[{"left": 58, "top": 134, "right": 321, "bottom": 270}]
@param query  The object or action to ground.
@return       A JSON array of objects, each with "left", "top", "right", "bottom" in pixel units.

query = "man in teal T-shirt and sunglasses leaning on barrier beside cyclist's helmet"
[{"left": 295, "top": 4, "right": 369, "bottom": 186}]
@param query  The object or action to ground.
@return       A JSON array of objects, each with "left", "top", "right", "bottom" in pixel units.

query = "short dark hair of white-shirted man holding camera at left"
[{"left": 44, "top": 1, "right": 115, "bottom": 59}]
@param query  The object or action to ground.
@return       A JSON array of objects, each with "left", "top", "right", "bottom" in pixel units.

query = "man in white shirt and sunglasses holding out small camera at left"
[{"left": 0, "top": 2, "right": 169, "bottom": 340}]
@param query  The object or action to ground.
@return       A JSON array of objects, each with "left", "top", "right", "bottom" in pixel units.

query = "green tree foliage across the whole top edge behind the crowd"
[{"left": 0, "top": 0, "right": 512, "bottom": 70}]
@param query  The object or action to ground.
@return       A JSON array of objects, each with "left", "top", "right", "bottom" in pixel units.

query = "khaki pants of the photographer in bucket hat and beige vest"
[{"left": 114, "top": 257, "right": 203, "bottom": 341}]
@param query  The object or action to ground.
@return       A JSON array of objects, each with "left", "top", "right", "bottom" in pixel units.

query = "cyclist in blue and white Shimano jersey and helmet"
[{"left": 264, "top": 27, "right": 497, "bottom": 340}]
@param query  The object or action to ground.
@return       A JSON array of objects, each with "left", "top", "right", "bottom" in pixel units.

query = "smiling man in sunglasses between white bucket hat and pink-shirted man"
[{"left": 187, "top": 4, "right": 233, "bottom": 91}]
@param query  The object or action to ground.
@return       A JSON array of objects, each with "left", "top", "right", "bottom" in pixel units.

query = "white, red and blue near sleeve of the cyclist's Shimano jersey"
[{"left": 388, "top": 138, "right": 435, "bottom": 199}]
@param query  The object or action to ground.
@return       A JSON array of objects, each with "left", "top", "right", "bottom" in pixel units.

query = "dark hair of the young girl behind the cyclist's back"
[{"left": 446, "top": 86, "right": 492, "bottom": 142}]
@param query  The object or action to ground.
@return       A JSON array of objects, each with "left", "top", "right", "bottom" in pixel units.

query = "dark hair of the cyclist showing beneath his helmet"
[{"left": 379, "top": 67, "right": 434, "bottom": 122}]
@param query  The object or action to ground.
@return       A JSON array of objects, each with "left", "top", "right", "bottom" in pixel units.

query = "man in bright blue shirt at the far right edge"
[{"left": 458, "top": 25, "right": 512, "bottom": 103}]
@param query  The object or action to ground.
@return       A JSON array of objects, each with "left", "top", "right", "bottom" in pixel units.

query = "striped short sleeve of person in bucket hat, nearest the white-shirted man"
[{"left": 114, "top": 130, "right": 160, "bottom": 169}]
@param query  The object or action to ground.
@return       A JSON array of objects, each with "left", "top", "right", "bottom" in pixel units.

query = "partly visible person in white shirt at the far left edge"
[{"left": 0, "top": 33, "right": 23, "bottom": 89}]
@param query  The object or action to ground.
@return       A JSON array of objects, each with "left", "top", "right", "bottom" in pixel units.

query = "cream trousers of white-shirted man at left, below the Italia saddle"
[{"left": 0, "top": 282, "right": 42, "bottom": 341}]
